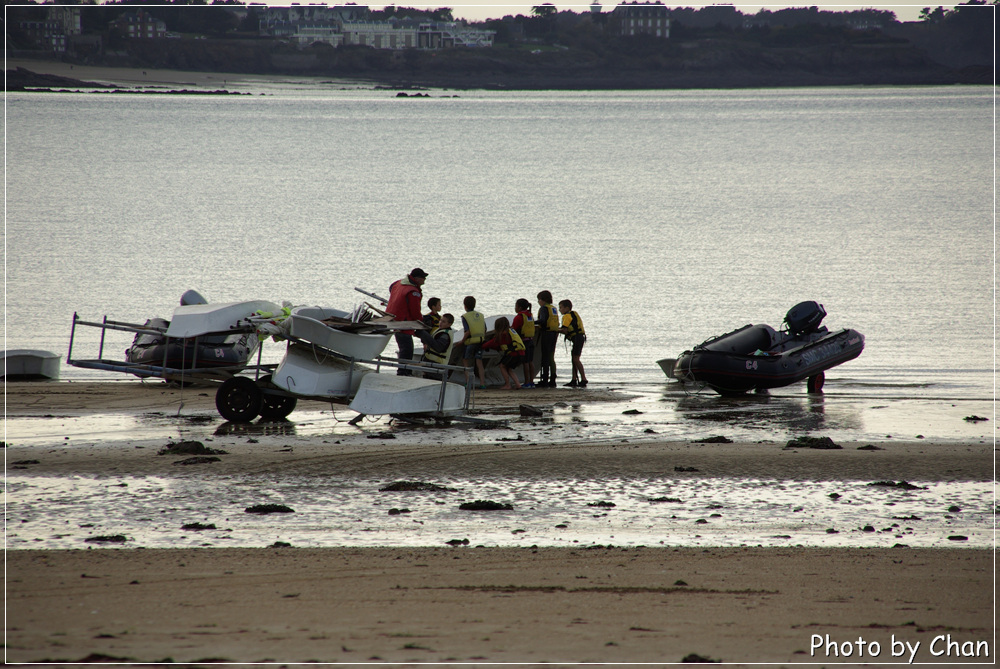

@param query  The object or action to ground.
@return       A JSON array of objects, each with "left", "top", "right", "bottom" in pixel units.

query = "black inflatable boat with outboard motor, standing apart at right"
[{"left": 673, "top": 302, "right": 865, "bottom": 395}]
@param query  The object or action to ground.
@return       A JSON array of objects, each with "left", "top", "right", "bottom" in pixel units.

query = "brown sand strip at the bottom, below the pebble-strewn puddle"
[{"left": 6, "top": 547, "right": 994, "bottom": 665}]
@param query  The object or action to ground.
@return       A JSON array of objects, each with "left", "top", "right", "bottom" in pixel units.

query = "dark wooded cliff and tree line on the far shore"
[{"left": 6, "top": 0, "right": 997, "bottom": 87}]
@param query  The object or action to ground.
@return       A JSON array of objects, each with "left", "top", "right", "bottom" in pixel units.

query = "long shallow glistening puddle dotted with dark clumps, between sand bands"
[{"left": 6, "top": 476, "right": 995, "bottom": 549}]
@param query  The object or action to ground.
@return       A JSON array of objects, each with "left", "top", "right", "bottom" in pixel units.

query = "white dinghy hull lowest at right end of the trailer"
[{"left": 350, "top": 374, "right": 465, "bottom": 416}]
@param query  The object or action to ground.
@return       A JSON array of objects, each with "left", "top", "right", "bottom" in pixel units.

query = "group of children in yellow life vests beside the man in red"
[{"left": 418, "top": 290, "right": 587, "bottom": 390}]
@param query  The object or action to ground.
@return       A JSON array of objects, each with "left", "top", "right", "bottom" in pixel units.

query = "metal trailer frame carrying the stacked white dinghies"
[{"left": 66, "top": 312, "right": 475, "bottom": 424}]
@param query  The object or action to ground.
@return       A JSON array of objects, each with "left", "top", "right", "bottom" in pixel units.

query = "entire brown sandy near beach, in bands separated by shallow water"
[{"left": 5, "top": 382, "right": 994, "bottom": 665}]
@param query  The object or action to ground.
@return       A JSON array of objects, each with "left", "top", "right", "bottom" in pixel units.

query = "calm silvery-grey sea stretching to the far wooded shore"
[{"left": 4, "top": 84, "right": 994, "bottom": 400}]
